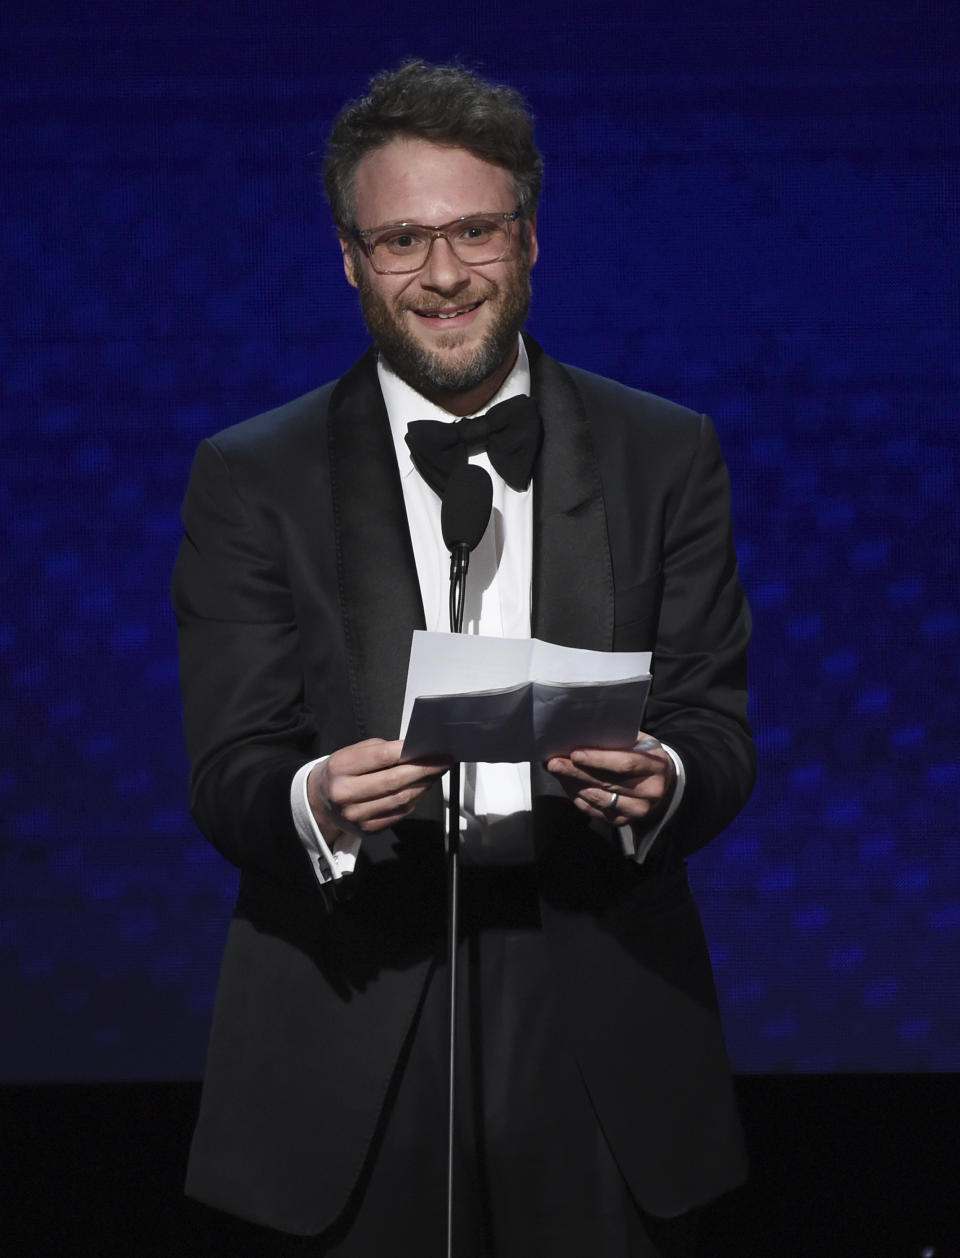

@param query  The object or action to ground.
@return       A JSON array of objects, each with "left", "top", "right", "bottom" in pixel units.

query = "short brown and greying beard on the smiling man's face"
[{"left": 356, "top": 257, "right": 530, "bottom": 399}]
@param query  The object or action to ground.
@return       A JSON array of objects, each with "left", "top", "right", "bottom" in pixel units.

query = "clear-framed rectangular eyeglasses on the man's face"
[{"left": 352, "top": 209, "right": 521, "bottom": 276}]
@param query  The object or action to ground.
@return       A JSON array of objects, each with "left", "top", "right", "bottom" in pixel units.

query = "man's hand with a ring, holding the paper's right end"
[{"left": 546, "top": 732, "right": 677, "bottom": 828}]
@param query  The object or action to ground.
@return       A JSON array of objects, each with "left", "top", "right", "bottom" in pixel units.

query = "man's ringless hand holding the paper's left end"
[{"left": 307, "top": 738, "right": 450, "bottom": 843}]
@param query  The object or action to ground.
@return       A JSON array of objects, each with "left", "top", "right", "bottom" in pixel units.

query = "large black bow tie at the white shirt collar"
[{"left": 405, "top": 396, "right": 544, "bottom": 497}]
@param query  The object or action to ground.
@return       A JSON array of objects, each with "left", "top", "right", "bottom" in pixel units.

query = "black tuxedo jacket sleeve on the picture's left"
[{"left": 172, "top": 442, "right": 318, "bottom": 892}]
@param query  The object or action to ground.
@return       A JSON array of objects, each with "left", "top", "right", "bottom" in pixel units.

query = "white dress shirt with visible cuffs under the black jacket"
[{"left": 291, "top": 338, "right": 684, "bottom": 883}]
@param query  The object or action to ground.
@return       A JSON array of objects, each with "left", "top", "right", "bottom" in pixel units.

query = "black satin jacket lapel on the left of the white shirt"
[{"left": 328, "top": 350, "right": 424, "bottom": 738}]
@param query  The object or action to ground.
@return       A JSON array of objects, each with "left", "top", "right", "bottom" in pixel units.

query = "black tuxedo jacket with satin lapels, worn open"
[{"left": 174, "top": 342, "right": 754, "bottom": 1234}]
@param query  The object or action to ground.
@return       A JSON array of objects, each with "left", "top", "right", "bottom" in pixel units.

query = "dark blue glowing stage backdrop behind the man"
[{"left": 0, "top": 0, "right": 960, "bottom": 1081}]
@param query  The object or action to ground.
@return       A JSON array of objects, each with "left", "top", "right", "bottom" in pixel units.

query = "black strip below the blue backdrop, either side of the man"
[{"left": 0, "top": 1076, "right": 960, "bottom": 1258}]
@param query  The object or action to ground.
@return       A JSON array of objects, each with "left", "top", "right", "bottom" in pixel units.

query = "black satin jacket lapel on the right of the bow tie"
[{"left": 526, "top": 337, "right": 614, "bottom": 650}]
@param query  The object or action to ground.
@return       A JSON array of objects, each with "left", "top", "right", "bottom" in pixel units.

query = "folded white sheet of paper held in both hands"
[{"left": 400, "top": 629, "right": 650, "bottom": 764}]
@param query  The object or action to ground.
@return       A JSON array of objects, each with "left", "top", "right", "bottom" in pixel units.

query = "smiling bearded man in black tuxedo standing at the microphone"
[{"left": 174, "top": 63, "right": 754, "bottom": 1258}]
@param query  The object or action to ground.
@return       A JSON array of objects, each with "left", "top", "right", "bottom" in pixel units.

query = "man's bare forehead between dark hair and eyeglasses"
[{"left": 354, "top": 138, "right": 516, "bottom": 228}]
